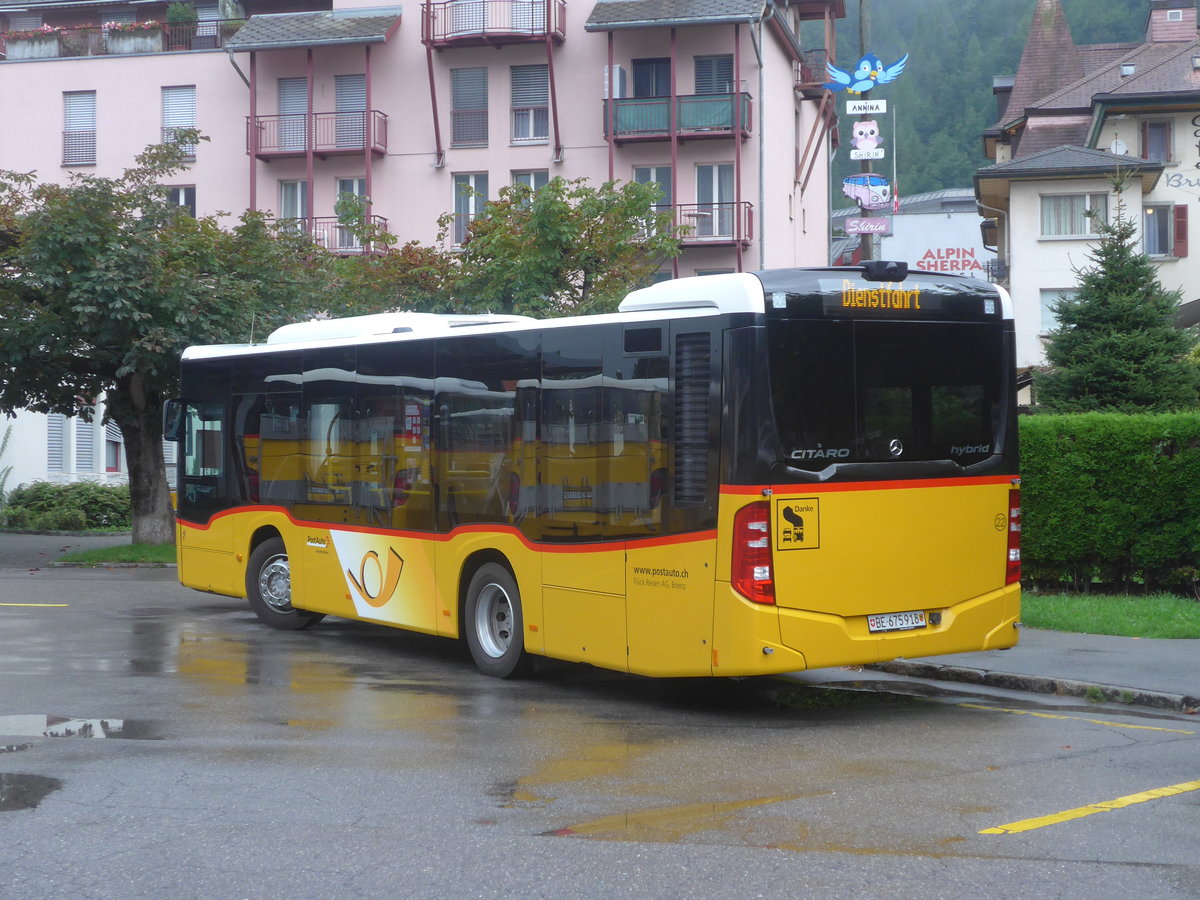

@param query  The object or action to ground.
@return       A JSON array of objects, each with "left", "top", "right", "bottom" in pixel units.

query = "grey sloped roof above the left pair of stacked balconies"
[{"left": 226, "top": 6, "right": 400, "bottom": 52}]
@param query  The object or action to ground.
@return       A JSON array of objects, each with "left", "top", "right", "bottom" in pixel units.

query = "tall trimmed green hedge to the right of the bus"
[{"left": 1021, "top": 413, "right": 1200, "bottom": 590}]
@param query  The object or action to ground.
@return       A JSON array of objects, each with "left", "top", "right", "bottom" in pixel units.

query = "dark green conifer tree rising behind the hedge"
[{"left": 1034, "top": 183, "right": 1200, "bottom": 413}]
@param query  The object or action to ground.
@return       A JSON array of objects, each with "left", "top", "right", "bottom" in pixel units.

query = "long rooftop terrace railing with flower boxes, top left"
[{"left": 0, "top": 19, "right": 246, "bottom": 61}]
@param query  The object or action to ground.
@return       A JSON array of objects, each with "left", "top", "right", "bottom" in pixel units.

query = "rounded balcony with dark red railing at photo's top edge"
[{"left": 421, "top": 0, "right": 566, "bottom": 48}]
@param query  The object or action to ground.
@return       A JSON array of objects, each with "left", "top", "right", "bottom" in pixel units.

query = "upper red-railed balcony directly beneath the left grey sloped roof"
[{"left": 246, "top": 109, "right": 388, "bottom": 160}]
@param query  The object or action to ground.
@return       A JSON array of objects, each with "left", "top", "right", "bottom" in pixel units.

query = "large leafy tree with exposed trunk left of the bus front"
[{"left": 0, "top": 130, "right": 325, "bottom": 542}]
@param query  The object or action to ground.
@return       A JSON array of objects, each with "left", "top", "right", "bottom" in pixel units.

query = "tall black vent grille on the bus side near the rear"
[{"left": 674, "top": 332, "right": 712, "bottom": 506}]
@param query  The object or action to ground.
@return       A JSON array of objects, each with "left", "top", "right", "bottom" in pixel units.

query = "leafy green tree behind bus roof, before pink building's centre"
[{"left": 440, "top": 178, "right": 679, "bottom": 316}]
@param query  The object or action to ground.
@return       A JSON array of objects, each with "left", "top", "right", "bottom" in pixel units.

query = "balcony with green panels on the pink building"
[{"left": 604, "top": 94, "right": 754, "bottom": 143}]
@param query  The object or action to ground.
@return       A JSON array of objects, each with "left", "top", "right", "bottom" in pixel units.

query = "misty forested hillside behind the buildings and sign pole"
[{"left": 816, "top": 0, "right": 1150, "bottom": 196}]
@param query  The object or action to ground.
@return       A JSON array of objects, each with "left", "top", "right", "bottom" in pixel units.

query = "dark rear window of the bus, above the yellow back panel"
[{"left": 767, "top": 319, "right": 1007, "bottom": 472}]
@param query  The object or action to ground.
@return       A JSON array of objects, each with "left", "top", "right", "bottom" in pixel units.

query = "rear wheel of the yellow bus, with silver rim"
[{"left": 464, "top": 563, "right": 528, "bottom": 678}]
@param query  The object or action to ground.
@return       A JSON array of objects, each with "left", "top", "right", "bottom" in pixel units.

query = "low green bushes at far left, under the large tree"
[{"left": 4, "top": 481, "right": 133, "bottom": 532}]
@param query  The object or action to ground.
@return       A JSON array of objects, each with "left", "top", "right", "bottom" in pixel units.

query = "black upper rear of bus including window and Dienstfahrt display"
[{"left": 725, "top": 270, "right": 1016, "bottom": 484}]
